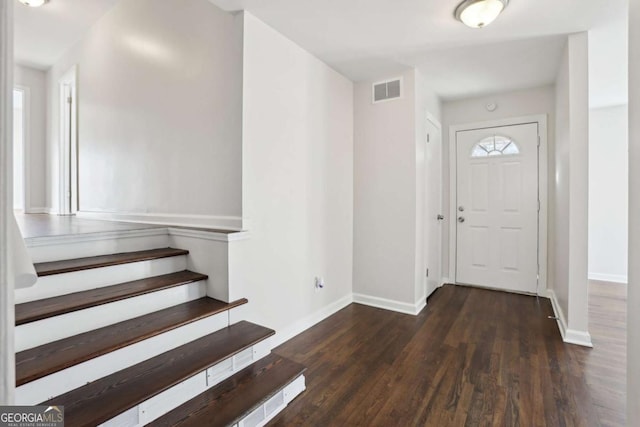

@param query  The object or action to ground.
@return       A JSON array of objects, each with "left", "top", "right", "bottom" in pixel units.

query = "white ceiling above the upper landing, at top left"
[{"left": 12, "top": 0, "right": 119, "bottom": 69}]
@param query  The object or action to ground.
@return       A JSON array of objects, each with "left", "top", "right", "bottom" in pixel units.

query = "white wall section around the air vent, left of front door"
[{"left": 353, "top": 69, "right": 440, "bottom": 313}]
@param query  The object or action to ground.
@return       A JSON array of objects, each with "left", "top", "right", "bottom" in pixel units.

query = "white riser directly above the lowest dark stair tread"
[{"left": 101, "top": 339, "right": 271, "bottom": 427}]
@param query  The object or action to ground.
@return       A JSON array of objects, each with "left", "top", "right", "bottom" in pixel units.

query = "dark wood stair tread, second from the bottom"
[{"left": 42, "top": 321, "right": 275, "bottom": 426}]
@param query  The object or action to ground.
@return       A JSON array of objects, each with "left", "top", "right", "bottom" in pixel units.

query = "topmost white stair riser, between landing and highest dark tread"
[{"left": 26, "top": 228, "right": 169, "bottom": 263}]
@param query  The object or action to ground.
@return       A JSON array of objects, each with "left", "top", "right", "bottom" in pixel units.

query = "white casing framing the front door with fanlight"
[{"left": 449, "top": 114, "right": 549, "bottom": 296}]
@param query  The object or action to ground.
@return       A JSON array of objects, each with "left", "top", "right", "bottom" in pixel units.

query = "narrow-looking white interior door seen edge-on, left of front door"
[{"left": 425, "top": 121, "right": 444, "bottom": 296}]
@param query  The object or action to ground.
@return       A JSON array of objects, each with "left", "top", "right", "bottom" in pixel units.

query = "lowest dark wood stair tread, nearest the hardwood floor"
[{"left": 148, "top": 353, "right": 306, "bottom": 427}]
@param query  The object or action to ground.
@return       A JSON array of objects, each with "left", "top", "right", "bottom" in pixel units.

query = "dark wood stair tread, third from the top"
[{"left": 16, "top": 297, "right": 247, "bottom": 386}]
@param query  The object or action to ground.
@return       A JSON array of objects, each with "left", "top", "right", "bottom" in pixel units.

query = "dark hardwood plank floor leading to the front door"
[{"left": 270, "top": 285, "right": 624, "bottom": 427}]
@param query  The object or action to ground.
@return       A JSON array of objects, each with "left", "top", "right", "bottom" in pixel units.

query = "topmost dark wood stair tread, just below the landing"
[{"left": 34, "top": 248, "right": 189, "bottom": 277}]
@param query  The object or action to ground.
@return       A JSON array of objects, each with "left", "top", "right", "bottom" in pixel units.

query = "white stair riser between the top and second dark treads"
[{"left": 15, "top": 255, "right": 187, "bottom": 304}]
